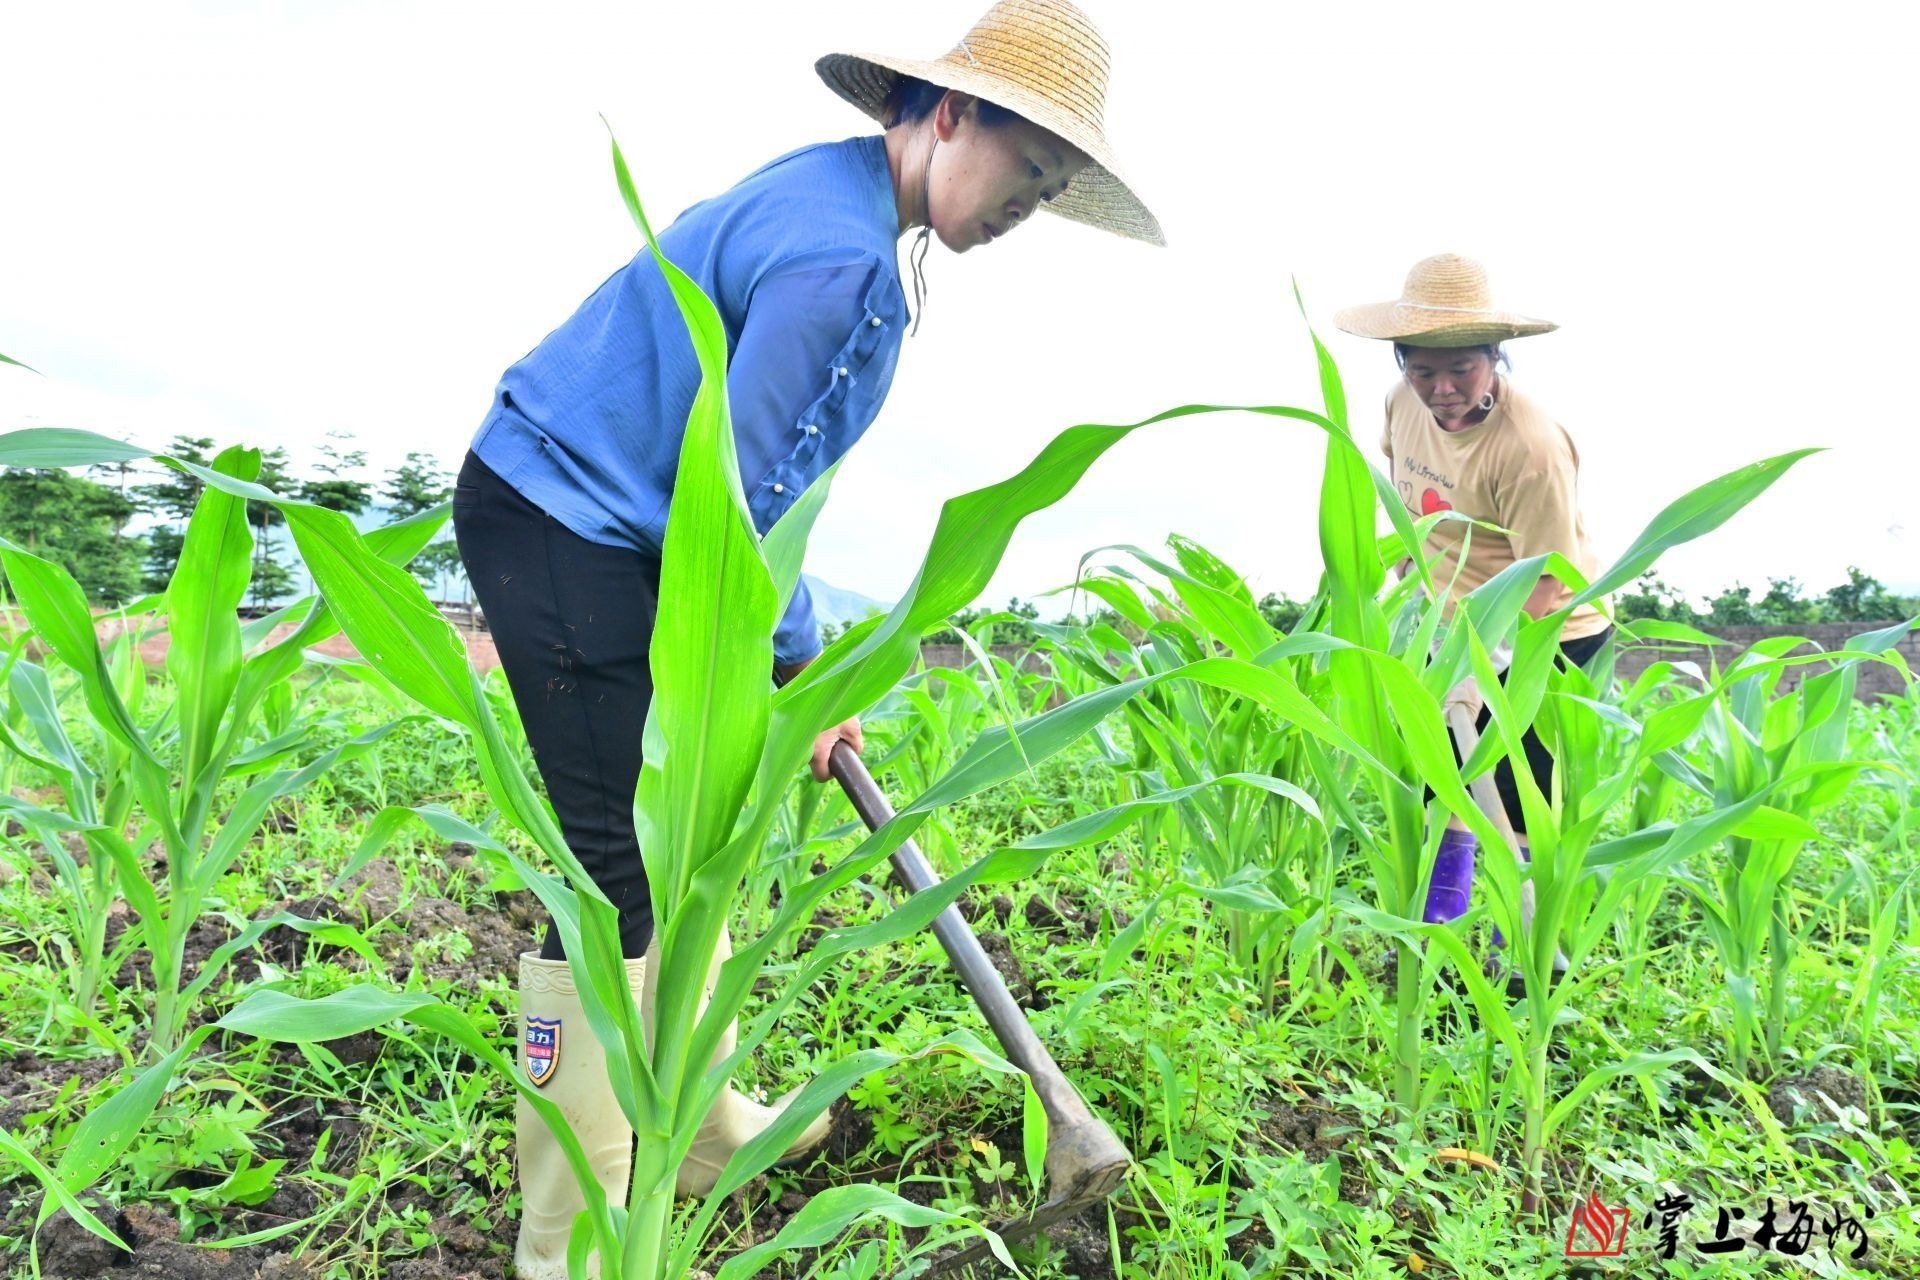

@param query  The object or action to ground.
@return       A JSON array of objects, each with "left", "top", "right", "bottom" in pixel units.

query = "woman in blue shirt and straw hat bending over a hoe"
[{"left": 453, "top": 0, "right": 1162, "bottom": 1278}]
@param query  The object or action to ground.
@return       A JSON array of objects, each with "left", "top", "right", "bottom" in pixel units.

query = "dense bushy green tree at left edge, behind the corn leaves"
[{"left": 0, "top": 470, "right": 146, "bottom": 604}]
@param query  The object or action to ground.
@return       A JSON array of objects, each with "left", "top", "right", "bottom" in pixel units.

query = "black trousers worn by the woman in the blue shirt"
[{"left": 453, "top": 451, "right": 660, "bottom": 960}]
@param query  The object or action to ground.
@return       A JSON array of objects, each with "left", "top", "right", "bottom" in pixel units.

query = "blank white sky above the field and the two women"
[{"left": 0, "top": 0, "right": 1920, "bottom": 604}]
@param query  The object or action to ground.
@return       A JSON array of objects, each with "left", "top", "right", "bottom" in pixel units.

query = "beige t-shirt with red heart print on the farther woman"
[{"left": 1380, "top": 378, "right": 1607, "bottom": 639}]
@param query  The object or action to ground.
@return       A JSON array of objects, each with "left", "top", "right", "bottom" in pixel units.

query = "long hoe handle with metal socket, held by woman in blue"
[{"left": 828, "top": 743, "right": 1133, "bottom": 1201}]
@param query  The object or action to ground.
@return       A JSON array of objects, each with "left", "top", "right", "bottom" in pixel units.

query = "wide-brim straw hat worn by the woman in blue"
[{"left": 814, "top": 0, "right": 1165, "bottom": 244}]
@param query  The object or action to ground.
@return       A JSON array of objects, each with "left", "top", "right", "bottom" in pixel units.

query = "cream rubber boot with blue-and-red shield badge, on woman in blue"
[{"left": 513, "top": 952, "right": 647, "bottom": 1280}]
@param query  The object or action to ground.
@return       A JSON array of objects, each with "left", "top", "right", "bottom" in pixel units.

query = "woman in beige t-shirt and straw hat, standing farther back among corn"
[{"left": 1334, "top": 253, "right": 1613, "bottom": 942}]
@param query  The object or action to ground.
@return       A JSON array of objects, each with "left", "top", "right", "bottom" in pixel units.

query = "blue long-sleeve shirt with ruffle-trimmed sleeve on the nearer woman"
[{"left": 472, "top": 134, "right": 906, "bottom": 662}]
